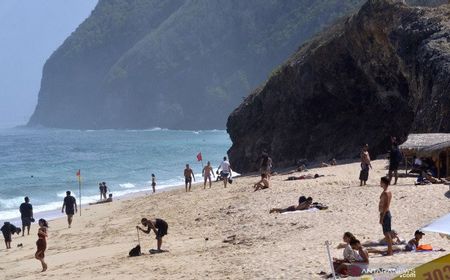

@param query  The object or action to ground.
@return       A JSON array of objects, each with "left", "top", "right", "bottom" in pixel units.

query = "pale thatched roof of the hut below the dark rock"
[{"left": 400, "top": 133, "right": 450, "bottom": 156}]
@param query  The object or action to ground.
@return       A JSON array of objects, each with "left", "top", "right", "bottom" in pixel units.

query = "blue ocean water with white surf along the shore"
[{"left": 0, "top": 128, "right": 231, "bottom": 220}]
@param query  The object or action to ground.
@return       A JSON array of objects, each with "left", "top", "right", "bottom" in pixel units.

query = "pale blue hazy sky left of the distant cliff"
[{"left": 0, "top": 0, "right": 97, "bottom": 127}]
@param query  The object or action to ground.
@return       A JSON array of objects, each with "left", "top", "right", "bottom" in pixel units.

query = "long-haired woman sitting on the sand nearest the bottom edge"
[{"left": 336, "top": 239, "right": 369, "bottom": 276}]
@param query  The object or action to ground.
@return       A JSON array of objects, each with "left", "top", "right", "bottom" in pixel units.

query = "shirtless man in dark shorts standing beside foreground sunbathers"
[{"left": 378, "top": 177, "right": 392, "bottom": 256}]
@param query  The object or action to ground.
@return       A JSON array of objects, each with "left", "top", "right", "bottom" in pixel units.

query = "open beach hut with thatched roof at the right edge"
[{"left": 399, "top": 133, "right": 450, "bottom": 178}]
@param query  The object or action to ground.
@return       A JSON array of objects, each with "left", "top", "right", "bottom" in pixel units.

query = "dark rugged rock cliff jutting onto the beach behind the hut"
[{"left": 227, "top": 0, "right": 450, "bottom": 172}]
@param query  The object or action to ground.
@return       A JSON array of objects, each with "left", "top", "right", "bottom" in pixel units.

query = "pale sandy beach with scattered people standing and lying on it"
[{"left": 0, "top": 160, "right": 450, "bottom": 279}]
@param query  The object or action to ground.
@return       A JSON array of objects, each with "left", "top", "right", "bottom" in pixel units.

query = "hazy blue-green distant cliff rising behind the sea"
[{"left": 29, "top": 0, "right": 362, "bottom": 129}]
